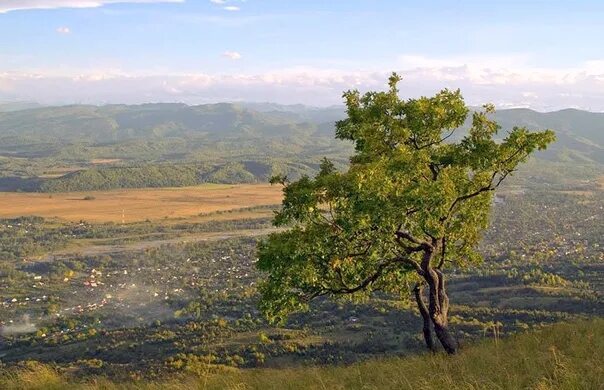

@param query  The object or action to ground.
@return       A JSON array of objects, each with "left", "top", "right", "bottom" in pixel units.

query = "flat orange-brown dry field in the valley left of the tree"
[{"left": 0, "top": 184, "right": 282, "bottom": 223}]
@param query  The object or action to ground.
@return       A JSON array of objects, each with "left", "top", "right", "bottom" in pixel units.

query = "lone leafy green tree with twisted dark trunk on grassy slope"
[{"left": 258, "top": 74, "right": 555, "bottom": 354}]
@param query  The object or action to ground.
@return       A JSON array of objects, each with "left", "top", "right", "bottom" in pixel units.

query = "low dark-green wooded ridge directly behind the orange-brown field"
[{"left": 34, "top": 161, "right": 316, "bottom": 192}]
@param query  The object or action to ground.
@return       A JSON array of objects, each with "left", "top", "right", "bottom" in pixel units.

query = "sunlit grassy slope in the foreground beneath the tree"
[{"left": 0, "top": 319, "right": 604, "bottom": 390}]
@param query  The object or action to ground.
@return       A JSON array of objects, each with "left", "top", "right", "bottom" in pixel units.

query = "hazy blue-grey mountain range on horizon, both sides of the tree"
[{"left": 0, "top": 103, "right": 604, "bottom": 152}]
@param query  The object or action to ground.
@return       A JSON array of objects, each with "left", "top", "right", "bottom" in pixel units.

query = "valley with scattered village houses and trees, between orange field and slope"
[{"left": 0, "top": 184, "right": 604, "bottom": 372}]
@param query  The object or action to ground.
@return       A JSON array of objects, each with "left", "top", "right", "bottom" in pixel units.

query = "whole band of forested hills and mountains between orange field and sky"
[{"left": 0, "top": 103, "right": 604, "bottom": 191}]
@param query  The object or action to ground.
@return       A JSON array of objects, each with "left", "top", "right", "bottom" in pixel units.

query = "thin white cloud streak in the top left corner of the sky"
[{"left": 0, "top": 0, "right": 185, "bottom": 13}]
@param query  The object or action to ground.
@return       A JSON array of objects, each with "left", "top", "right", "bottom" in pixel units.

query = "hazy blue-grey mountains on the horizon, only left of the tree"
[{"left": 0, "top": 103, "right": 334, "bottom": 145}]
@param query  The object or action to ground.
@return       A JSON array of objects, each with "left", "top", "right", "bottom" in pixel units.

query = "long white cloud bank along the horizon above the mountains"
[{"left": 0, "top": 58, "right": 604, "bottom": 111}]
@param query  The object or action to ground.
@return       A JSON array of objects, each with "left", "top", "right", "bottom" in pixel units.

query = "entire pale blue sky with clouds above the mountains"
[{"left": 0, "top": 0, "right": 604, "bottom": 111}]
